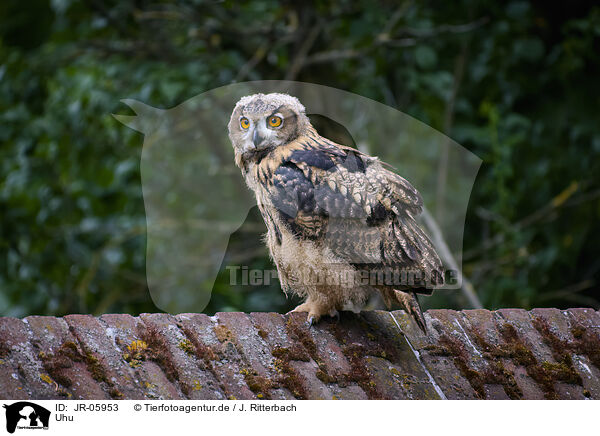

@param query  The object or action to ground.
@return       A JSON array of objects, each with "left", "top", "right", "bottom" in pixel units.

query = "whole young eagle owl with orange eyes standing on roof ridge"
[{"left": 228, "top": 93, "right": 443, "bottom": 331}]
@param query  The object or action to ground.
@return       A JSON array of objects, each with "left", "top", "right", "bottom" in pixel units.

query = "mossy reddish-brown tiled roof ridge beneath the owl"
[{"left": 0, "top": 309, "right": 600, "bottom": 400}]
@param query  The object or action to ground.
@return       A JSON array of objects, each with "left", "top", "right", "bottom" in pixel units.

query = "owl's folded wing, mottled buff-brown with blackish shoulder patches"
[{"left": 253, "top": 131, "right": 443, "bottom": 292}]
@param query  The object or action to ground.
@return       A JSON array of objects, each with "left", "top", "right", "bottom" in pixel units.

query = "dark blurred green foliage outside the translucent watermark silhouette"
[{"left": 0, "top": 0, "right": 600, "bottom": 316}]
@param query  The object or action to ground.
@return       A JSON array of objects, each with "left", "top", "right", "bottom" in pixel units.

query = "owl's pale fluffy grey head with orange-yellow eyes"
[{"left": 228, "top": 93, "right": 310, "bottom": 165}]
